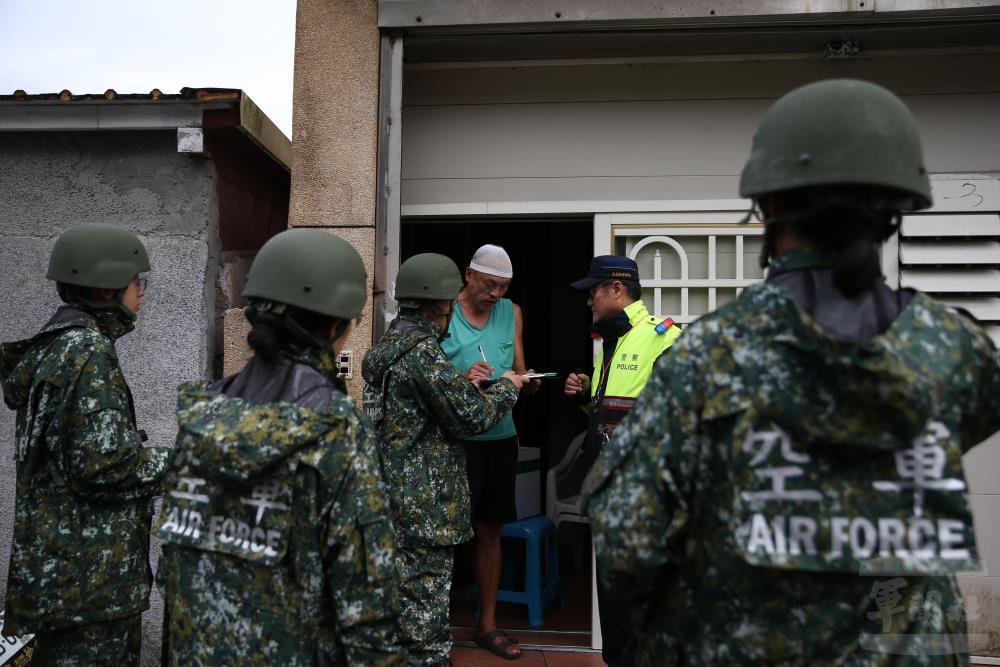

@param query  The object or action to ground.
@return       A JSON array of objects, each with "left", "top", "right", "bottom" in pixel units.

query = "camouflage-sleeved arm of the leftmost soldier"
[{"left": 54, "top": 352, "right": 170, "bottom": 499}]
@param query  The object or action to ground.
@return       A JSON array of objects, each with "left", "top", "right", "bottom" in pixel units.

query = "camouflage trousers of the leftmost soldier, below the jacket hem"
[{"left": 30, "top": 615, "right": 142, "bottom": 667}]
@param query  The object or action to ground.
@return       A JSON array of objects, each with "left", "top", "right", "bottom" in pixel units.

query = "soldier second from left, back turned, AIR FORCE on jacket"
[{"left": 157, "top": 229, "right": 406, "bottom": 667}]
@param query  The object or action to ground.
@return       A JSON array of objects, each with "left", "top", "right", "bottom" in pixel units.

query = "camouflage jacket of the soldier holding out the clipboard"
[{"left": 362, "top": 310, "right": 518, "bottom": 546}]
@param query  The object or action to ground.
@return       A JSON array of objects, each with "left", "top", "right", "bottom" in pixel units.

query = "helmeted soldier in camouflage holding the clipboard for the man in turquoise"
[{"left": 362, "top": 253, "right": 524, "bottom": 666}]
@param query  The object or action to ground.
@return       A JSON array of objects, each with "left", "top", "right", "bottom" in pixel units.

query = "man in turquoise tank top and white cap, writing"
[{"left": 441, "top": 245, "right": 539, "bottom": 660}]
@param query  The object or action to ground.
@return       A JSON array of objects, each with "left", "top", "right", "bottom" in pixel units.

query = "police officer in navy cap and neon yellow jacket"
[{"left": 563, "top": 255, "right": 681, "bottom": 665}]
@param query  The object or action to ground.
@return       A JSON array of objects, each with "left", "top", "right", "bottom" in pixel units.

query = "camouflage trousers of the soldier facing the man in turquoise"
[{"left": 396, "top": 547, "right": 454, "bottom": 667}]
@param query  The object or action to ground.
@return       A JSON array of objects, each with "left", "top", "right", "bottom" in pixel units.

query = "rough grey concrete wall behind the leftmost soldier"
[{"left": 0, "top": 132, "right": 219, "bottom": 665}]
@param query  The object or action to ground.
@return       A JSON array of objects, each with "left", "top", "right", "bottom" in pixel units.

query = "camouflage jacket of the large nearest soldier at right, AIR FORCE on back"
[{"left": 584, "top": 274, "right": 1000, "bottom": 665}]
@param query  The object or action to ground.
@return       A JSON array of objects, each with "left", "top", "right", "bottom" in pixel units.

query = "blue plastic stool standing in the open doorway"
[{"left": 497, "top": 516, "right": 563, "bottom": 628}]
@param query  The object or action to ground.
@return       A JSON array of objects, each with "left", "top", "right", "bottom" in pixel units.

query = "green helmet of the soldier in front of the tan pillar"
[{"left": 243, "top": 229, "right": 368, "bottom": 320}]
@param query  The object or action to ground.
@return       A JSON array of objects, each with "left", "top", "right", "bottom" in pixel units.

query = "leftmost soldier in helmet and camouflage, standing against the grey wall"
[{"left": 0, "top": 225, "right": 169, "bottom": 665}]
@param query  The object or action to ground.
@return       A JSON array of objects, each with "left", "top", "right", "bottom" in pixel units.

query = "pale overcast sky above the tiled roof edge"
[{"left": 0, "top": 0, "right": 295, "bottom": 138}]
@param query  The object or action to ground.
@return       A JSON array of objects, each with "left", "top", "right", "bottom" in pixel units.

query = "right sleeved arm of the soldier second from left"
[{"left": 324, "top": 420, "right": 407, "bottom": 665}]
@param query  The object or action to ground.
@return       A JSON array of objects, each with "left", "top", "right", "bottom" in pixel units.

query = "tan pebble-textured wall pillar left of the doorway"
[{"left": 290, "top": 0, "right": 379, "bottom": 404}]
